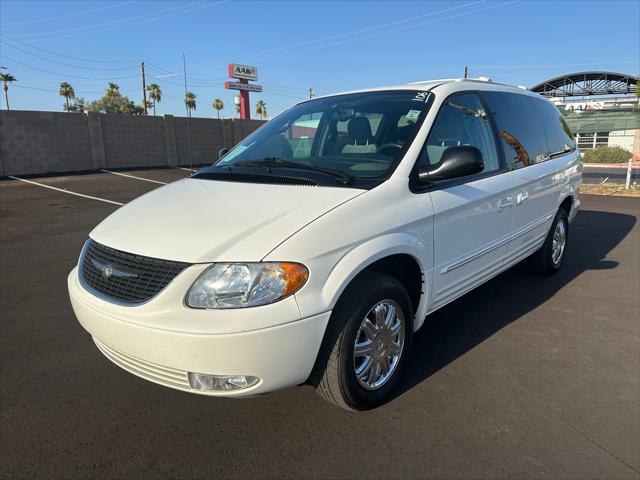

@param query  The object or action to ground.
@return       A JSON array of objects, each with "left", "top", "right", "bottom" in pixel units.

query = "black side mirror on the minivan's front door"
[{"left": 418, "top": 146, "right": 484, "bottom": 183}]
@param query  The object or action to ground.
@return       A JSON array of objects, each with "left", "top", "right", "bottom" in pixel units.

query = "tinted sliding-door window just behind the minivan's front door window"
[{"left": 482, "top": 92, "right": 549, "bottom": 169}]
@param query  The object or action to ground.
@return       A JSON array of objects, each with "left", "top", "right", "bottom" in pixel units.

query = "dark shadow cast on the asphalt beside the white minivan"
[{"left": 394, "top": 210, "right": 636, "bottom": 397}]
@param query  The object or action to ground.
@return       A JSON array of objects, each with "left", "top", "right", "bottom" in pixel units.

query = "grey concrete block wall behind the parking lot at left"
[{"left": 0, "top": 110, "right": 264, "bottom": 176}]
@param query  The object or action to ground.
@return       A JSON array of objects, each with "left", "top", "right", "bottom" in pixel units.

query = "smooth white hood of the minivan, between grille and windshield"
[{"left": 90, "top": 178, "right": 365, "bottom": 263}]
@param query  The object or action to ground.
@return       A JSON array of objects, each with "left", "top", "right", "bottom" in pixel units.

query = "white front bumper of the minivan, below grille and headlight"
[{"left": 67, "top": 268, "right": 331, "bottom": 396}]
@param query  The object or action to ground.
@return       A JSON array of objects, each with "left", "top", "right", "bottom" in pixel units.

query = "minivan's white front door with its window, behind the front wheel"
[{"left": 421, "top": 93, "right": 516, "bottom": 310}]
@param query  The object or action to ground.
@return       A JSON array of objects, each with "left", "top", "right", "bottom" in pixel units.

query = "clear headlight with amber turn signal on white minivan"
[{"left": 186, "top": 263, "right": 309, "bottom": 308}]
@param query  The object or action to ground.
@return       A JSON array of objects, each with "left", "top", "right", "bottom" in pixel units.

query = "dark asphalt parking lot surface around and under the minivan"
[{"left": 0, "top": 169, "right": 640, "bottom": 479}]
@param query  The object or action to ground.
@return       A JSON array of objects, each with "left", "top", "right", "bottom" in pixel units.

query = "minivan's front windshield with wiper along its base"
[{"left": 216, "top": 90, "right": 430, "bottom": 187}]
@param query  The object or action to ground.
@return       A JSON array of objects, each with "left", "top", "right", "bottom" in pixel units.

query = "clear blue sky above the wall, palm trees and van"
[{"left": 0, "top": 0, "right": 640, "bottom": 118}]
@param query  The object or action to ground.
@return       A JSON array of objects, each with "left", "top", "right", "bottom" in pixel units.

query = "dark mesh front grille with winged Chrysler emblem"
[{"left": 81, "top": 240, "right": 189, "bottom": 304}]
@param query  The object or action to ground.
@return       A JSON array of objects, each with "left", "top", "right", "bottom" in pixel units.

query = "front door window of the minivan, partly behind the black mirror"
[{"left": 425, "top": 93, "right": 500, "bottom": 172}]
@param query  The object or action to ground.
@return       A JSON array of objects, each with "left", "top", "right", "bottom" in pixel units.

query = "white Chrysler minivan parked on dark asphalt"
[{"left": 68, "top": 79, "right": 582, "bottom": 410}]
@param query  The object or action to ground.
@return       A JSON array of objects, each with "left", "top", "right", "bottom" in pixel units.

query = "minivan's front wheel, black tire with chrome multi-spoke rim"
[{"left": 311, "top": 272, "right": 413, "bottom": 410}]
